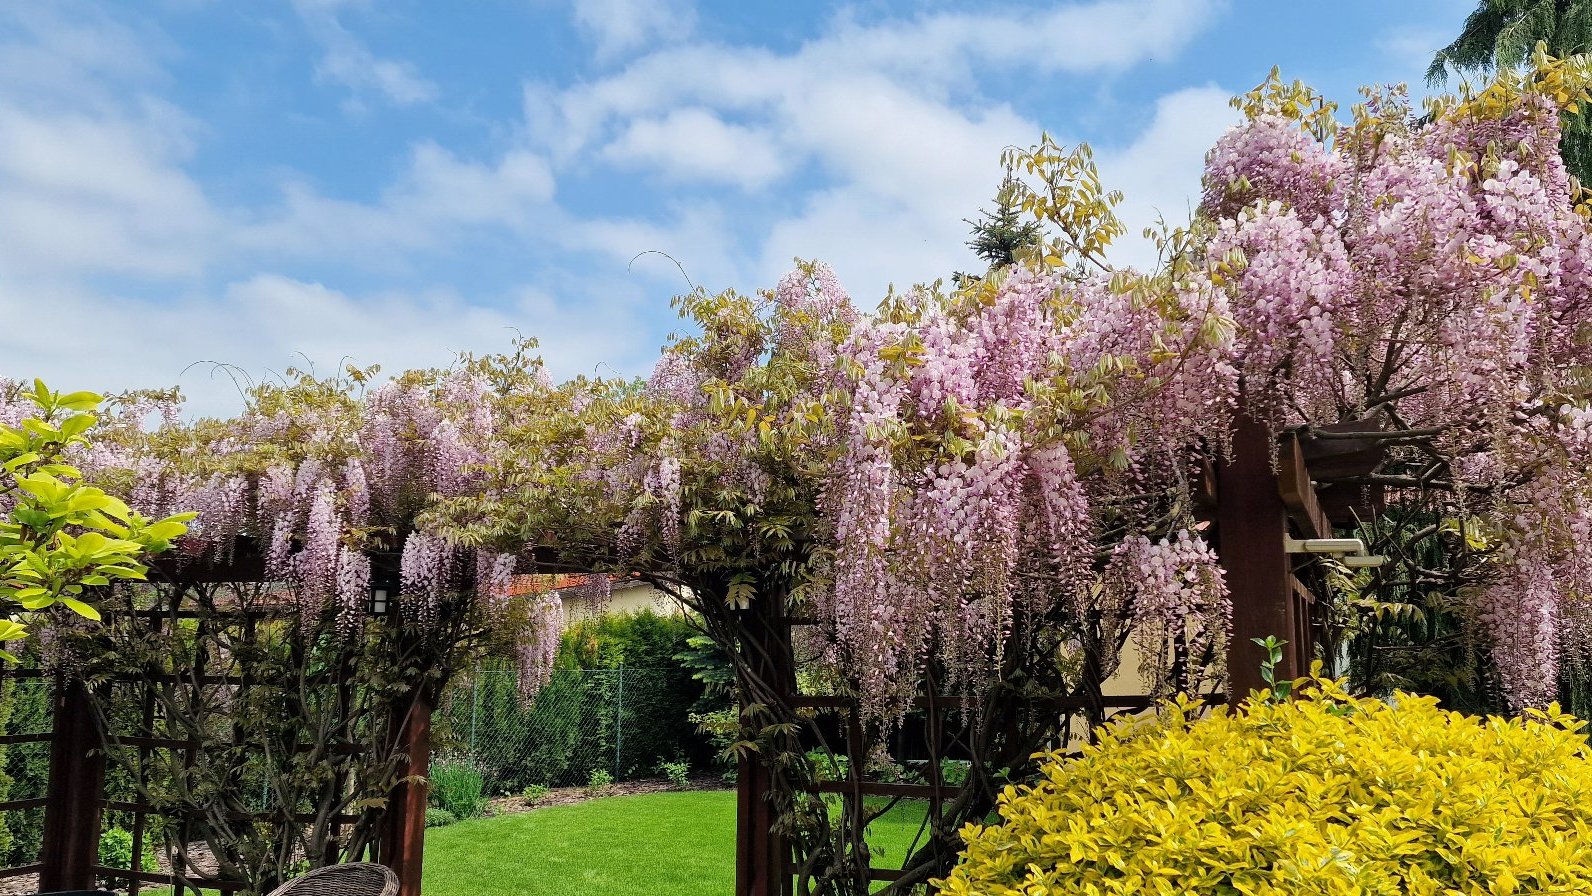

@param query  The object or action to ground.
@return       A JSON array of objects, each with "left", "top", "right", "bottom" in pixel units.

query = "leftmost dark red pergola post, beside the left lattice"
[{"left": 38, "top": 675, "right": 105, "bottom": 891}]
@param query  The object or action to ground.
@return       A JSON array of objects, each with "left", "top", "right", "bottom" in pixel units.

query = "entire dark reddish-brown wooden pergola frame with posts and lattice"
[{"left": 0, "top": 410, "right": 1382, "bottom": 896}]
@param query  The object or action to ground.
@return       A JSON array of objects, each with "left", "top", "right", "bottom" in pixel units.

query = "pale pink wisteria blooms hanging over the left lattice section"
[{"left": 83, "top": 366, "right": 559, "bottom": 700}]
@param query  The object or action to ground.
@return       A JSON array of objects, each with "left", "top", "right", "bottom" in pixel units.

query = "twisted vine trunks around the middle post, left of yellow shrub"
[{"left": 661, "top": 576, "right": 1121, "bottom": 896}]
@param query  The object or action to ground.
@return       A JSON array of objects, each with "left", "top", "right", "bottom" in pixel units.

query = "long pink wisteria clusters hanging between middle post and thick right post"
[{"left": 820, "top": 269, "right": 1231, "bottom": 716}]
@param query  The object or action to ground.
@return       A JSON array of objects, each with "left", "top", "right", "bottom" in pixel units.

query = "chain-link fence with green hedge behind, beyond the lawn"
[{"left": 435, "top": 665, "right": 710, "bottom": 794}]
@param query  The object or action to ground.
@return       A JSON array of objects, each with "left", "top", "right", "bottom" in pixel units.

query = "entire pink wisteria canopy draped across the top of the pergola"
[{"left": 8, "top": 59, "right": 1592, "bottom": 718}]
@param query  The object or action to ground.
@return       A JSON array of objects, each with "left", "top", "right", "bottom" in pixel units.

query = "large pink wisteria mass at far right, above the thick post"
[{"left": 1205, "top": 59, "right": 1592, "bottom": 707}]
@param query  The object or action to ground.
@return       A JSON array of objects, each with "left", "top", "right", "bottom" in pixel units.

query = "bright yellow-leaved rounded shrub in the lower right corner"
[{"left": 942, "top": 680, "right": 1592, "bottom": 896}]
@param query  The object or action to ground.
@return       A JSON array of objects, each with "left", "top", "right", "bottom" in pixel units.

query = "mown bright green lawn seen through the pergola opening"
[{"left": 425, "top": 791, "right": 923, "bottom": 896}]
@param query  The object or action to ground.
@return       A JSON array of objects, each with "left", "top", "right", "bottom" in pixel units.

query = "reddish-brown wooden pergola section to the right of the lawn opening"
[{"left": 736, "top": 419, "right": 1383, "bottom": 896}]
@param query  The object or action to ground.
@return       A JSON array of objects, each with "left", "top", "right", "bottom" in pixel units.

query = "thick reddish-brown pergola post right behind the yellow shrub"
[{"left": 1216, "top": 404, "right": 1310, "bottom": 703}]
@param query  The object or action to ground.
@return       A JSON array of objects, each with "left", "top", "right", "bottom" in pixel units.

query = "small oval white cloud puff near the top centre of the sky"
[{"left": 602, "top": 107, "right": 786, "bottom": 189}]
